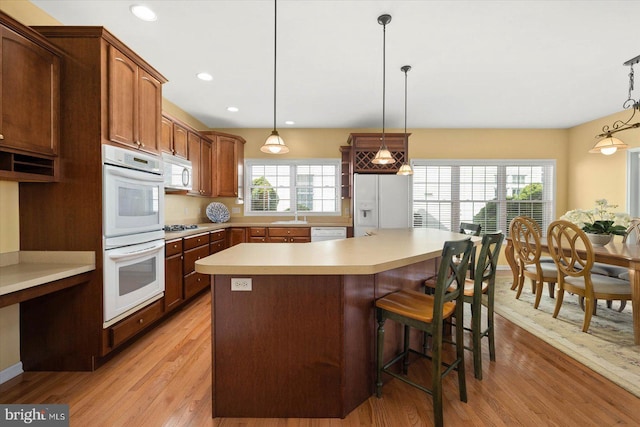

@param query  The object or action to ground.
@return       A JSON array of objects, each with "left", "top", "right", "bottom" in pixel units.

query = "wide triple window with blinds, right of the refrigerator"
[{"left": 412, "top": 160, "right": 555, "bottom": 234}]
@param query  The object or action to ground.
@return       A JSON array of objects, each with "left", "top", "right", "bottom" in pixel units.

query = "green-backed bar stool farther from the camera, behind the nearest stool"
[{"left": 456, "top": 231, "right": 504, "bottom": 380}]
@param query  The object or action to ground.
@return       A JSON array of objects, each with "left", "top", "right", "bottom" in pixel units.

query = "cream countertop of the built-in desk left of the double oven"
[{"left": 0, "top": 251, "right": 96, "bottom": 295}]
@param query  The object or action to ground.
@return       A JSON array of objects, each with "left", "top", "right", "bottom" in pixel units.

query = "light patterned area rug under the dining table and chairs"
[{"left": 495, "top": 276, "right": 640, "bottom": 397}]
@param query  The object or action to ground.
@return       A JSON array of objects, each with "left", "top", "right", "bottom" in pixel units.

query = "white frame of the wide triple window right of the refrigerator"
[{"left": 411, "top": 159, "right": 557, "bottom": 235}]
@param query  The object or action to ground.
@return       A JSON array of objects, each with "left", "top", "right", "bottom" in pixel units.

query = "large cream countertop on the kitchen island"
[{"left": 195, "top": 228, "right": 481, "bottom": 275}]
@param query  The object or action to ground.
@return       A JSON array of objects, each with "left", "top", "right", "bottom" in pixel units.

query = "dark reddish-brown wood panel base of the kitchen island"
[{"left": 211, "top": 261, "right": 433, "bottom": 418}]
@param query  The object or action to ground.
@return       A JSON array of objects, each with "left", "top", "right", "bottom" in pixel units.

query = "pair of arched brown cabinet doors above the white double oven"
[{"left": 108, "top": 45, "right": 162, "bottom": 154}]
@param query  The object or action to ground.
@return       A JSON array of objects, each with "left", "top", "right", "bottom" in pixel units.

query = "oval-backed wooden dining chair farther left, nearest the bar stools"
[{"left": 509, "top": 216, "right": 558, "bottom": 308}]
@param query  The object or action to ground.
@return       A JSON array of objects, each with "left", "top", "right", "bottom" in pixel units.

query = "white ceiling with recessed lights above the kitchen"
[{"left": 32, "top": 0, "right": 640, "bottom": 130}]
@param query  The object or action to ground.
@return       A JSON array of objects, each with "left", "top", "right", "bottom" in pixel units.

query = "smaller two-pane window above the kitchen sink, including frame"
[{"left": 245, "top": 159, "right": 340, "bottom": 216}]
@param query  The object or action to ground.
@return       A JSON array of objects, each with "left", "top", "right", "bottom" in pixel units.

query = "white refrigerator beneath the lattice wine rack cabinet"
[{"left": 353, "top": 174, "right": 412, "bottom": 237}]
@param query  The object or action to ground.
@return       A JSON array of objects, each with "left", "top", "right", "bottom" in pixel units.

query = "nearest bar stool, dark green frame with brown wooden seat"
[{"left": 375, "top": 239, "right": 473, "bottom": 426}]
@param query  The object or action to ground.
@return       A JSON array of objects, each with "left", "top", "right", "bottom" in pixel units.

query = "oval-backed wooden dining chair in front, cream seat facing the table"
[{"left": 547, "top": 220, "right": 631, "bottom": 332}]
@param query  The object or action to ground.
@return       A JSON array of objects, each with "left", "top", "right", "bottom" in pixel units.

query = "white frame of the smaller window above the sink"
[{"left": 244, "top": 158, "right": 342, "bottom": 217}]
